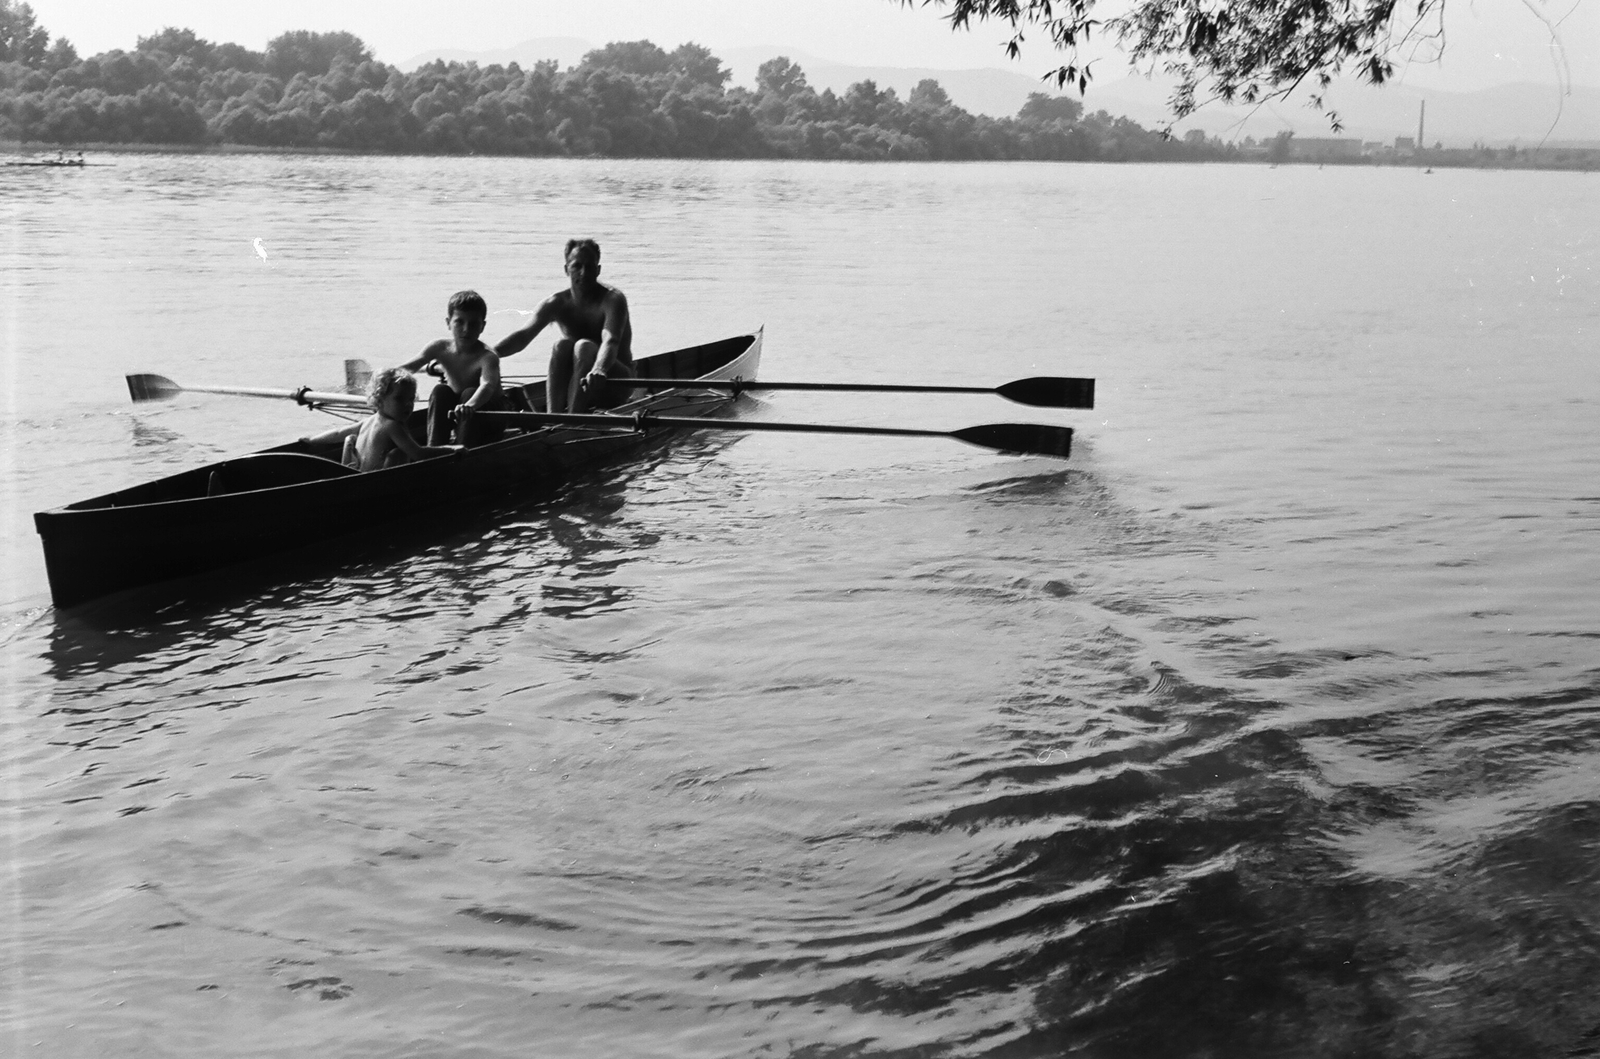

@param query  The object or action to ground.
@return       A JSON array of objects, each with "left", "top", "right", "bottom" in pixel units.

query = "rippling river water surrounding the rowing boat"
[{"left": 0, "top": 155, "right": 1600, "bottom": 1057}]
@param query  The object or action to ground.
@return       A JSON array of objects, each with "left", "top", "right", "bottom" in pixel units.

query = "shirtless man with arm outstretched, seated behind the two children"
[{"left": 494, "top": 238, "right": 634, "bottom": 413}]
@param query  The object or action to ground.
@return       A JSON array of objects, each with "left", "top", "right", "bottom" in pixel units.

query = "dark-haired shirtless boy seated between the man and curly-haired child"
[{"left": 400, "top": 291, "right": 506, "bottom": 448}]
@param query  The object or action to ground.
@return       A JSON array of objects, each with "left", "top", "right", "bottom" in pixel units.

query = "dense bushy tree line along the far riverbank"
[{"left": 0, "top": 0, "right": 1232, "bottom": 162}]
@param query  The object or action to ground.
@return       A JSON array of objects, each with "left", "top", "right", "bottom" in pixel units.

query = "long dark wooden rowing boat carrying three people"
[{"left": 34, "top": 331, "right": 762, "bottom": 608}]
